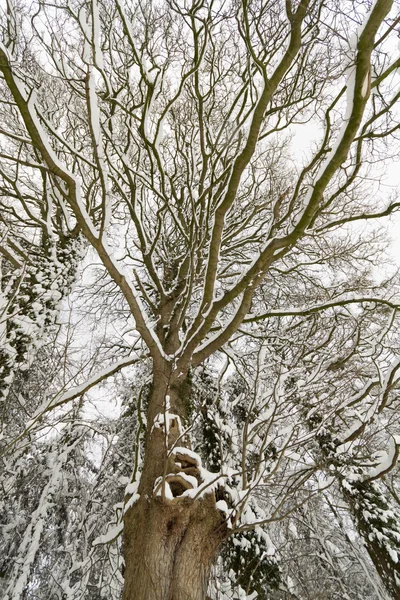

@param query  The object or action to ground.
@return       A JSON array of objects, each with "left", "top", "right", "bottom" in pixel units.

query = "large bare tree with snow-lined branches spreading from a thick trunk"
[{"left": 0, "top": 0, "right": 400, "bottom": 600}]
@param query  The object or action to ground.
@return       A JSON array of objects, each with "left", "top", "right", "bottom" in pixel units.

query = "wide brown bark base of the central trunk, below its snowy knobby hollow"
[{"left": 123, "top": 495, "right": 226, "bottom": 600}]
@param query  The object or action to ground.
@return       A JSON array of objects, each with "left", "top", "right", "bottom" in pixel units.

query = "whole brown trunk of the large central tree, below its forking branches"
[{"left": 123, "top": 371, "right": 227, "bottom": 600}]
